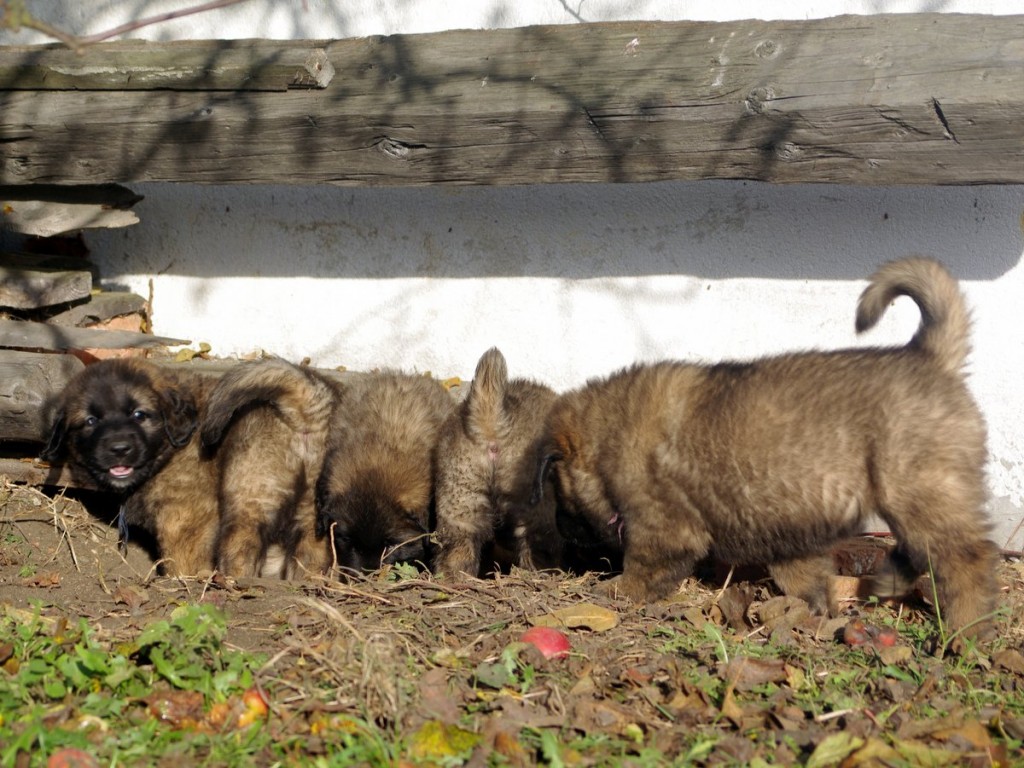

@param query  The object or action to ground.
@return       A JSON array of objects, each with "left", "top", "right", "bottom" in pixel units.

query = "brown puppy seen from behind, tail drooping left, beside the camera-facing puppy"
[{"left": 202, "top": 358, "right": 340, "bottom": 579}]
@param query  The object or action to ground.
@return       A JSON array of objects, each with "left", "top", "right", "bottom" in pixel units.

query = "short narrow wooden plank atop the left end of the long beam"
[{"left": 0, "top": 40, "right": 334, "bottom": 91}]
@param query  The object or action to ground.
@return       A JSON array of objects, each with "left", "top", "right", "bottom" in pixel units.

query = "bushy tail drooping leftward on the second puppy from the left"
[{"left": 201, "top": 358, "right": 337, "bottom": 447}]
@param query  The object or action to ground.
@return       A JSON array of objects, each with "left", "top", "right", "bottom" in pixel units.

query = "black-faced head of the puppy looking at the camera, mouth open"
[{"left": 43, "top": 360, "right": 195, "bottom": 494}]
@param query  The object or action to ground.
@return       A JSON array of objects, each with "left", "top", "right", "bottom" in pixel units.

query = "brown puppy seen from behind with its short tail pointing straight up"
[{"left": 436, "top": 348, "right": 564, "bottom": 575}]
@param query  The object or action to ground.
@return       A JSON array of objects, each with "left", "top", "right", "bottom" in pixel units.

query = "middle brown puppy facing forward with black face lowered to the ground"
[{"left": 316, "top": 372, "right": 455, "bottom": 572}]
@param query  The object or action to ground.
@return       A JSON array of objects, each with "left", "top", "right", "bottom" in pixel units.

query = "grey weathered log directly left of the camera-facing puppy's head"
[{"left": 0, "top": 350, "right": 84, "bottom": 441}]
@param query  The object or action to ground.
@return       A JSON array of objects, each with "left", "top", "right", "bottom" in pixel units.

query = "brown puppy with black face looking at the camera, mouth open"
[{"left": 41, "top": 358, "right": 217, "bottom": 575}]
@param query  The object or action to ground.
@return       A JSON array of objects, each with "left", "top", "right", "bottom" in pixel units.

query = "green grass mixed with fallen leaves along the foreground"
[{"left": 0, "top": 593, "right": 1024, "bottom": 768}]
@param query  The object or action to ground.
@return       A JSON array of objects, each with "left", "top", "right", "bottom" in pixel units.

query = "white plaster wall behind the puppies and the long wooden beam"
[{"left": 0, "top": 0, "right": 1024, "bottom": 548}]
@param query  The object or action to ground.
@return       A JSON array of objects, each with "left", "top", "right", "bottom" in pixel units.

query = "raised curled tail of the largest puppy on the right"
[{"left": 857, "top": 256, "right": 971, "bottom": 374}]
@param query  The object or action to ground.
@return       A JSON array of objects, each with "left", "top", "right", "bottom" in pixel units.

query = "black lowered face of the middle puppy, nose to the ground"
[{"left": 317, "top": 489, "right": 430, "bottom": 572}]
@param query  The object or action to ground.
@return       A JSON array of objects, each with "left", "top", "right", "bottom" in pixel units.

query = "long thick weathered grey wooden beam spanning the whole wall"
[{"left": 0, "top": 13, "right": 1024, "bottom": 185}]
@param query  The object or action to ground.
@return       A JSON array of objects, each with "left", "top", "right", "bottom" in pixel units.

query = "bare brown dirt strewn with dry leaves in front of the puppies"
[{"left": 0, "top": 479, "right": 1024, "bottom": 765}]
